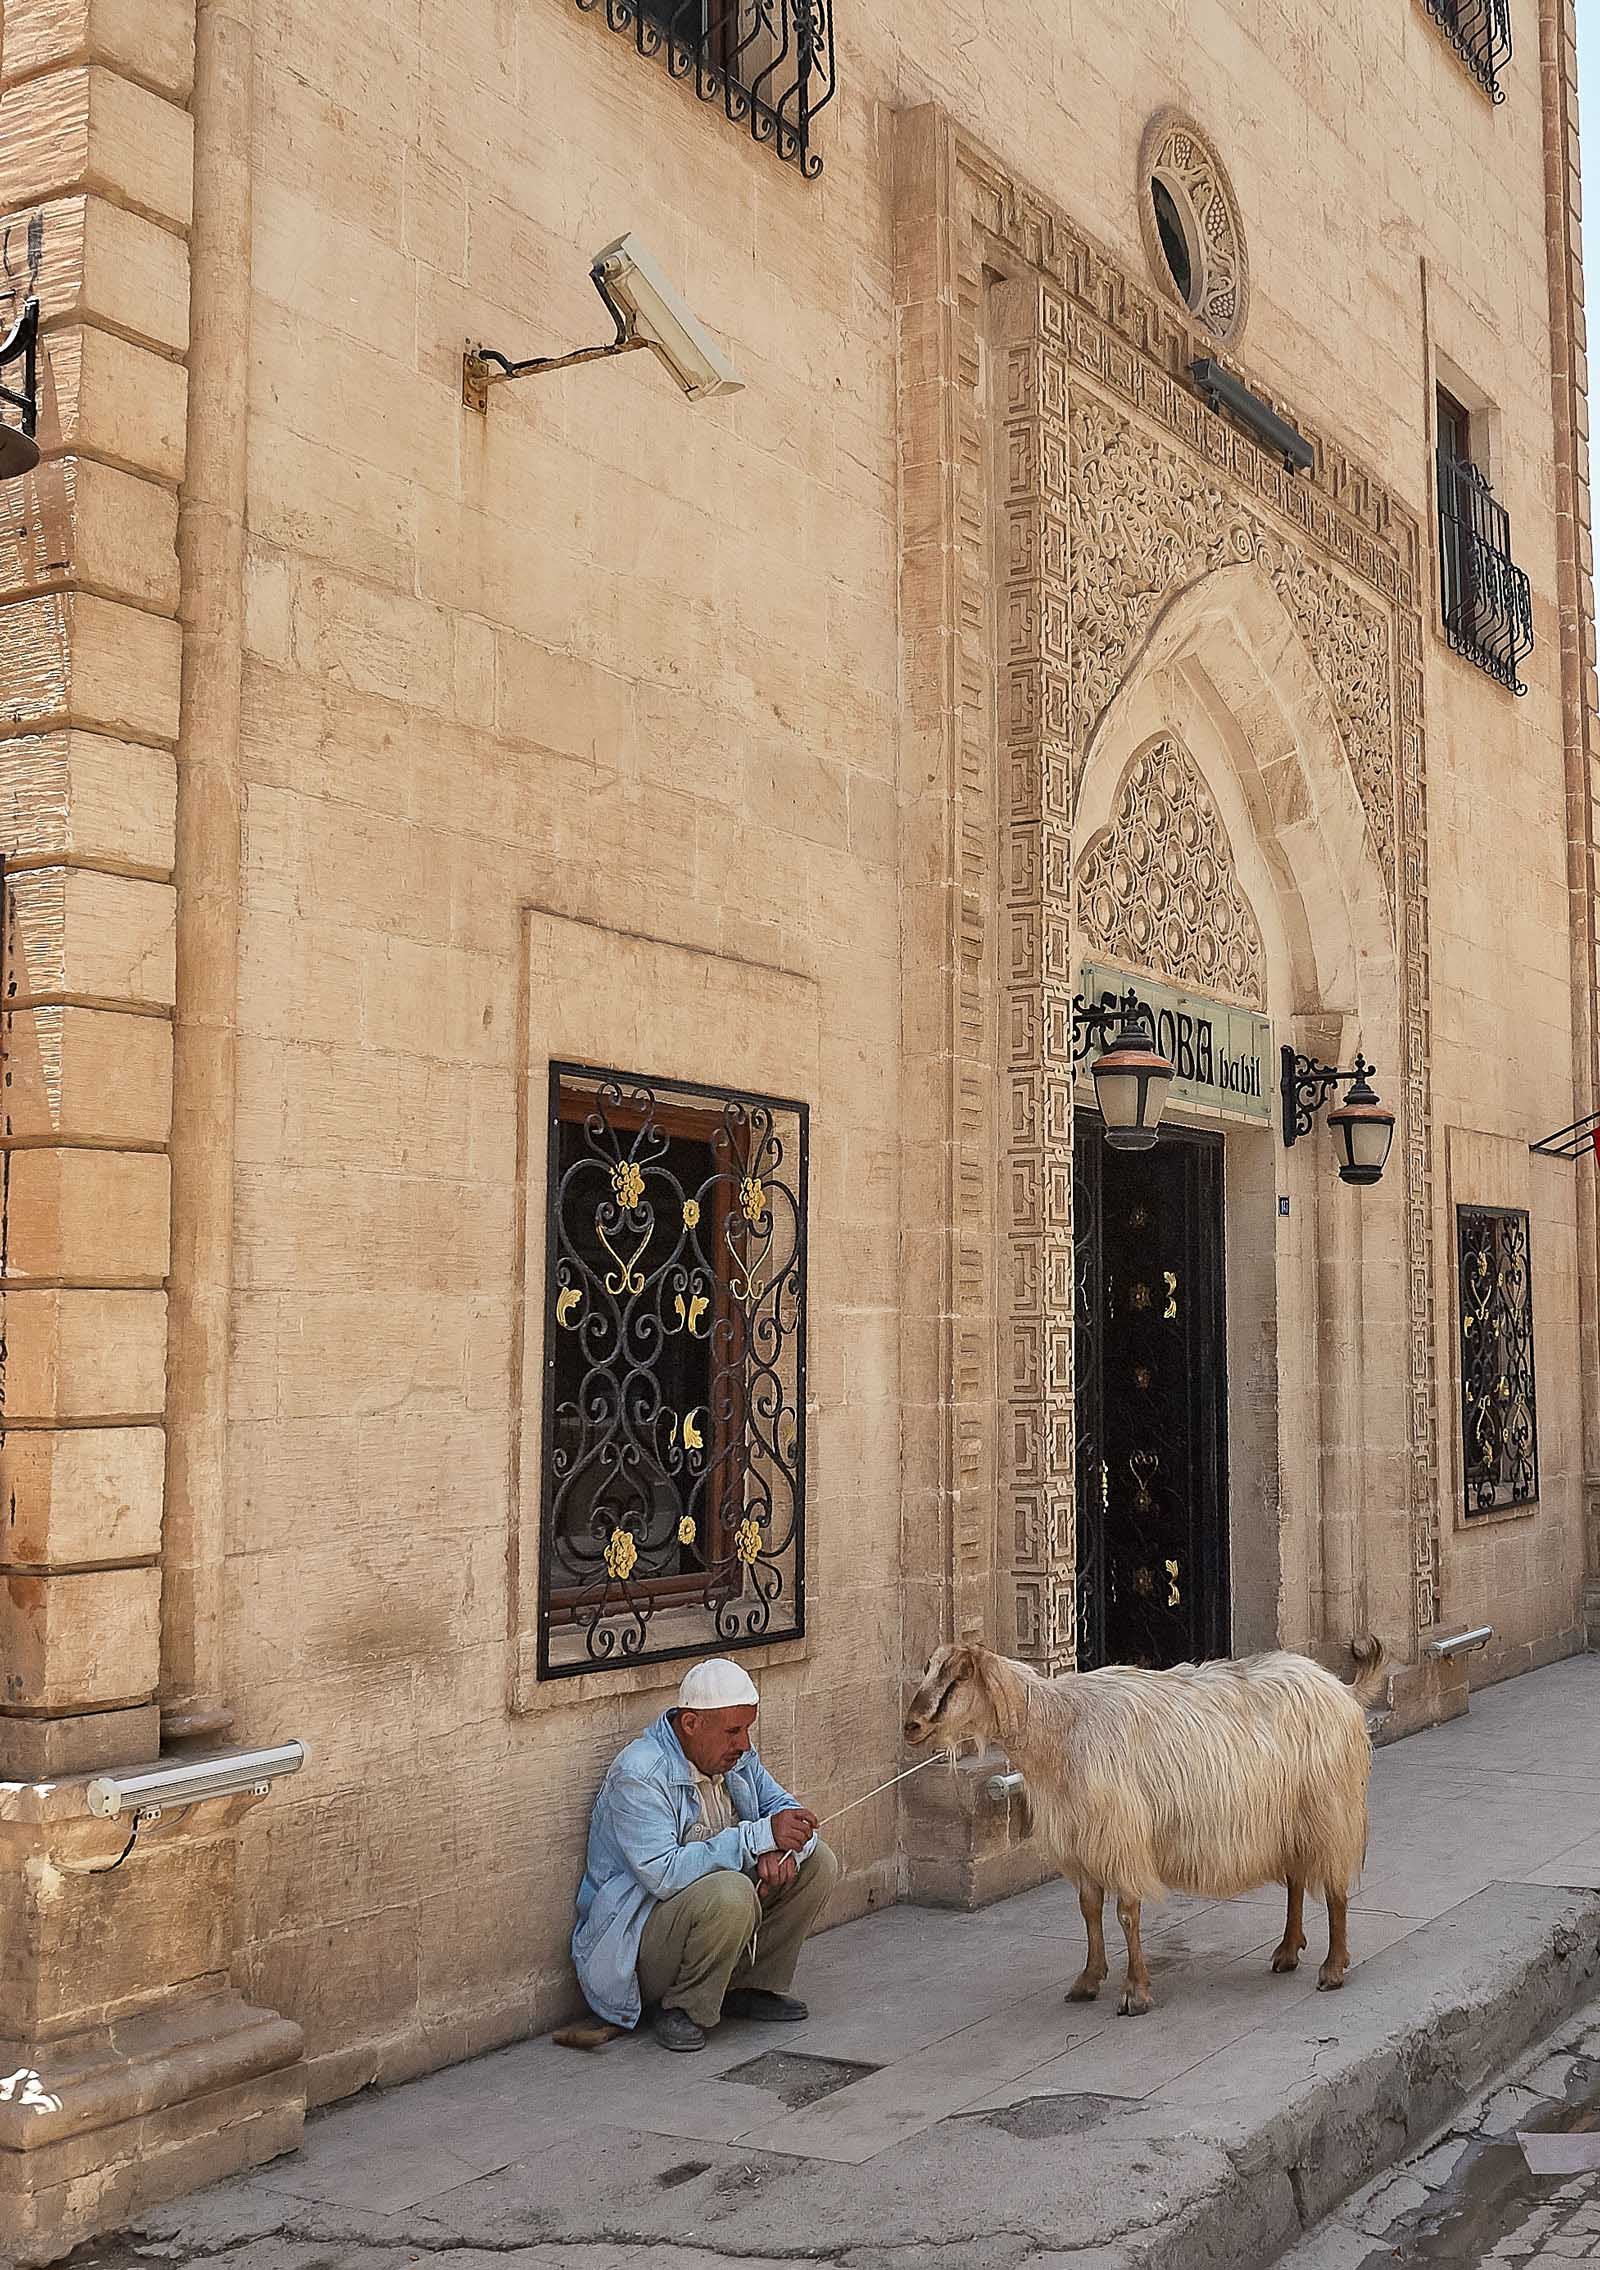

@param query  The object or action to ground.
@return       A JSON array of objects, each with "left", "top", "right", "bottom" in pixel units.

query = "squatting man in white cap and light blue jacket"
[{"left": 572, "top": 1657, "right": 840, "bottom": 2050}]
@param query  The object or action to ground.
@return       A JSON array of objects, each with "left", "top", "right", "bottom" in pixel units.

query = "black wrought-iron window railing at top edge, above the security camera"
[{"left": 576, "top": 0, "right": 833, "bottom": 179}]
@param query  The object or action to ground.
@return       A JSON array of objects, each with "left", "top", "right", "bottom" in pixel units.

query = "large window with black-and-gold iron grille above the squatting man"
[{"left": 540, "top": 1065, "right": 808, "bottom": 1678}]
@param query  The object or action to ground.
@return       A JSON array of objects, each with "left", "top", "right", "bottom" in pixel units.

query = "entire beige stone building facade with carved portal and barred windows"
[{"left": 0, "top": 0, "right": 1600, "bottom": 2261}]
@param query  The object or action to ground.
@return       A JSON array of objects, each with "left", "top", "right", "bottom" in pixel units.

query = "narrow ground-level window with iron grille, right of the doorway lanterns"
[{"left": 1455, "top": 1205, "right": 1539, "bottom": 1514}]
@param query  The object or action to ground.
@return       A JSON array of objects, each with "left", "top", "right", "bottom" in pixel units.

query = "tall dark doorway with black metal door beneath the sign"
[{"left": 1073, "top": 1108, "right": 1228, "bottom": 1671}]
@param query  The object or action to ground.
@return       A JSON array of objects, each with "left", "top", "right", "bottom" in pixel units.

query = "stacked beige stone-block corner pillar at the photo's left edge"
[{"left": 0, "top": 0, "right": 193, "bottom": 1777}]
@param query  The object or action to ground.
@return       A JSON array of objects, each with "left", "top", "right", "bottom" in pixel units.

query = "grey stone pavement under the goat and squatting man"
[{"left": 100, "top": 1657, "right": 1600, "bottom": 2270}]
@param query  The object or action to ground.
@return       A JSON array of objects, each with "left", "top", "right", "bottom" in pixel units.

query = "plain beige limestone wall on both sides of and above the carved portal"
[{"left": 220, "top": 0, "right": 1580, "bottom": 2093}]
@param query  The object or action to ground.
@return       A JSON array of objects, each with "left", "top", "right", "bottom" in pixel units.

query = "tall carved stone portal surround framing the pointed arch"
[{"left": 896, "top": 111, "right": 1439, "bottom": 1707}]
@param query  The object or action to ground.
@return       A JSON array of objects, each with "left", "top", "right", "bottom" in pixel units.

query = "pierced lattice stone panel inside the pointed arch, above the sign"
[{"left": 1076, "top": 735, "right": 1266, "bottom": 1010}]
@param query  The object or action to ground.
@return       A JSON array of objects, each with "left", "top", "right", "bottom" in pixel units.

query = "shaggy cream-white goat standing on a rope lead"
[{"left": 906, "top": 1639, "right": 1384, "bottom": 2016}]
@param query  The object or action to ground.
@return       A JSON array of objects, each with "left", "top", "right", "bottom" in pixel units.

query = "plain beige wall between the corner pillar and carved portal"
[{"left": 225, "top": 0, "right": 903, "bottom": 2093}]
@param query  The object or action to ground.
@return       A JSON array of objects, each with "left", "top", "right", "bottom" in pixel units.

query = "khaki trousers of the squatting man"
[{"left": 638, "top": 1843, "right": 840, "bottom": 2027}]
